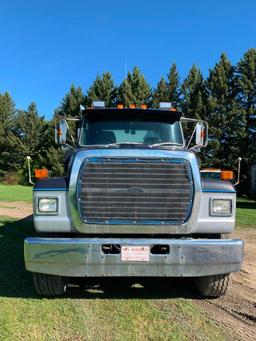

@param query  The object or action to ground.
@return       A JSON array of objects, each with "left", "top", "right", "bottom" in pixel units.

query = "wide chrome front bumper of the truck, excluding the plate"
[{"left": 24, "top": 238, "right": 243, "bottom": 277}]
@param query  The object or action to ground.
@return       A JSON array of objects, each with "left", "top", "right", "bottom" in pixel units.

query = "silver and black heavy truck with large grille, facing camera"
[{"left": 24, "top": 102, "right": 244, "bottom": 297}]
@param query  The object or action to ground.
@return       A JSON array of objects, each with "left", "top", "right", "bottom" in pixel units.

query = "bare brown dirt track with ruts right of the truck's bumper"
[{"left": 195, "top": 230, "right": 256, "bottom": 340}]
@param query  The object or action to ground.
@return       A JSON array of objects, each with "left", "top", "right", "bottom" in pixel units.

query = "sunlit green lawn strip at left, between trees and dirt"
[{"left": 0, "top": 184, "right": 32, "bottom": 202}]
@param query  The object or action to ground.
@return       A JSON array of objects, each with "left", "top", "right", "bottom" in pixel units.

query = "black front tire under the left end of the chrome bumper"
[{"left": 32, "top": 272, "right": 66, "bottom": 297}]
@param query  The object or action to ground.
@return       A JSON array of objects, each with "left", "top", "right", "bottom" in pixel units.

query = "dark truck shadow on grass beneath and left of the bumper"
[{"left": 0, "top": 217, "right": 198, "bottom": 299}]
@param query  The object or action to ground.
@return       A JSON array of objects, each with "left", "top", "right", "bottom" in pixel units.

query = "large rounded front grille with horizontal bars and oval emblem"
[{"left": 77, "top": 158, "right": 193, "bottom": 224}]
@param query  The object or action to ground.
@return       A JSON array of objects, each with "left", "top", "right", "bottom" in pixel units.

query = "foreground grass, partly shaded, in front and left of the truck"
[{"left": 0, "top": 218, "right": 227, "bottom": 341}]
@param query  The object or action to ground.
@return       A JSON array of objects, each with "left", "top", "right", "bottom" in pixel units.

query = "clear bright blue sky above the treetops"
[{"left": 0, "top": 0, "right": 256, "bottom": 119}]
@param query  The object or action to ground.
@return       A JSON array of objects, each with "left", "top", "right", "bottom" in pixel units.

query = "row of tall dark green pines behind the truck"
[{"left": 0, "top": 49, "right": 256, "bottom": 192}]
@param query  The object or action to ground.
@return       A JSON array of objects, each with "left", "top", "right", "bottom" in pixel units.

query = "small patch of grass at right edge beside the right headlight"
[{"left": 236, "top": 198, "right": 256, "bottom": 228}]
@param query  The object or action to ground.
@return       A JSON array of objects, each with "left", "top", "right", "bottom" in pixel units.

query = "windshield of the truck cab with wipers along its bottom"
[{"left": 80, "top": 120, "right": 183, "bottom": 146}]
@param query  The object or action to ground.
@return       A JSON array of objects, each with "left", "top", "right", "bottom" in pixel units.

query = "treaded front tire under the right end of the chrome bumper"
[{"left": 195, "top": 274, "right": 229, "bottom": 297}]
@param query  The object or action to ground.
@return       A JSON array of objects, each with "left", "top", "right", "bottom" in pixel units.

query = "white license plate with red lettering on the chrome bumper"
[{"left": 121, "top": 246, "right": 150, "bottom": 262}]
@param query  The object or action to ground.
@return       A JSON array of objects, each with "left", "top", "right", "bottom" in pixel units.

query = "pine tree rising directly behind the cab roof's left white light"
[{"left": 87, "top": 72, "right": 116, "bottom": 107}]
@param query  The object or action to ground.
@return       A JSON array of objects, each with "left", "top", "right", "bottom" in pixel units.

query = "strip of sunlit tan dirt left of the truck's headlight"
[{"left": 0, "top": 201, "right": 32, "bottom": 219}]
